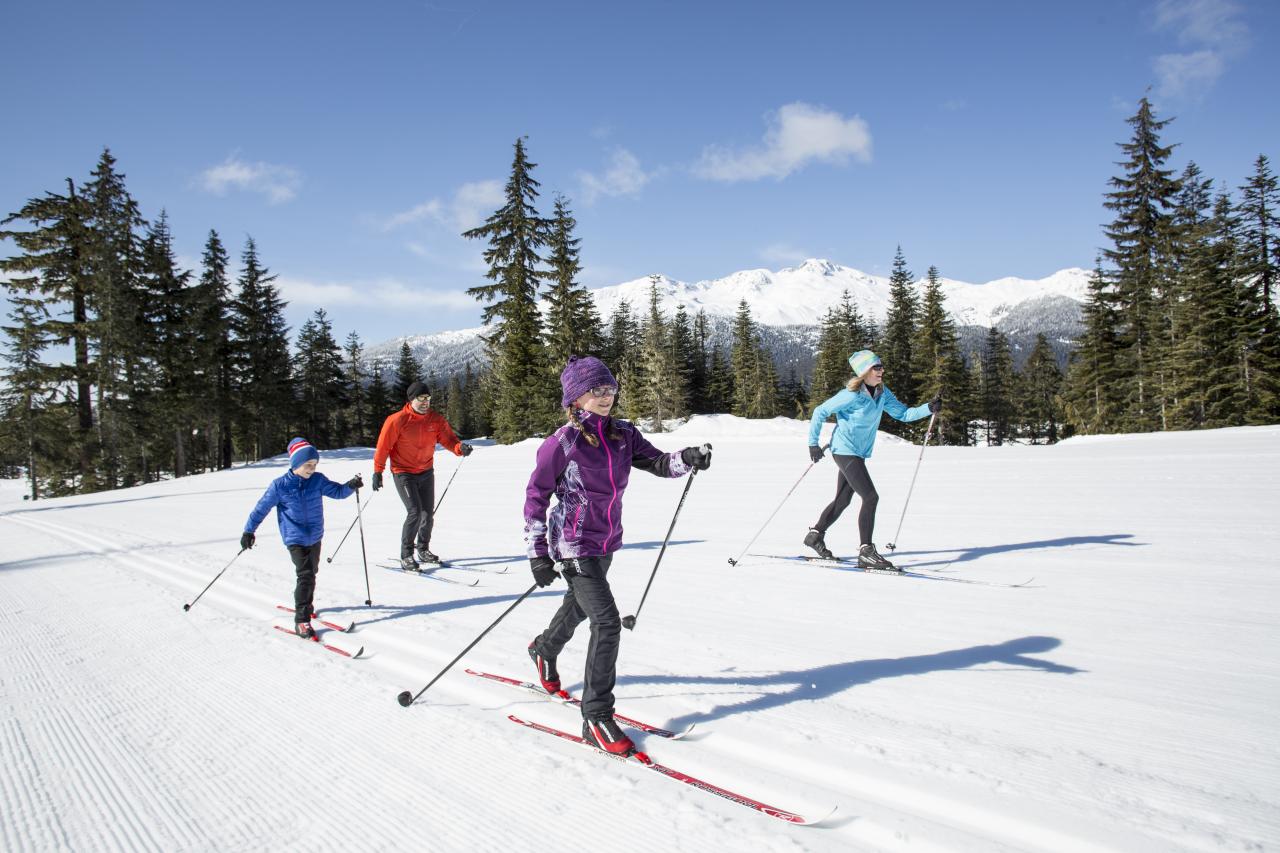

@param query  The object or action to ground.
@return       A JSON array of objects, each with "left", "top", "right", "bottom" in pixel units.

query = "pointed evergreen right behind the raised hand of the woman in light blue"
[{"left": 911, "top": 266, "right": 970, "bottom": 444}]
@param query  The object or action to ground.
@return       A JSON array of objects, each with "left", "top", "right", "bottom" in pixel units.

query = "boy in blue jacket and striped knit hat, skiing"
[{"left": 241, "top": 438, "right": 364, "bottom": 630}]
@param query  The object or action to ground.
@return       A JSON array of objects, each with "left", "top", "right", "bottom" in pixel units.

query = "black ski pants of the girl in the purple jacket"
[{"left": 534, "top": 555, "right": 622, "bottom": 720}]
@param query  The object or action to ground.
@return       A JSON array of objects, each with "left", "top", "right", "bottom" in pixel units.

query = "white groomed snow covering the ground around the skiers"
[{"left": 0, "top": 415, "right": 1280, "bottom": 850}]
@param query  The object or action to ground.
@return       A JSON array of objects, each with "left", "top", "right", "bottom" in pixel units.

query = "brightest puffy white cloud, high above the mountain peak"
[{"left": 694, "top": 101, "right": 872, "bottom": 182}]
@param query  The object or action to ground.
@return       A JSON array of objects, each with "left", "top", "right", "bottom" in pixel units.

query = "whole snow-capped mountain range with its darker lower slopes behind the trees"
[{"left": 367, "top": 259, "right": 1089, "bottom": 380}]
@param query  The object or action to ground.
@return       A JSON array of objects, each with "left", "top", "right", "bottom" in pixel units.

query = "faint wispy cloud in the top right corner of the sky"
[{"left": 1152, "top": 0, "right": 1249, "bottom": 97}]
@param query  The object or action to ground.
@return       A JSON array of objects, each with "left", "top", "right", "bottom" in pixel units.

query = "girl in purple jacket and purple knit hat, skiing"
[{"left": 525, "top": 356, "right": 712, "bottom": 756}]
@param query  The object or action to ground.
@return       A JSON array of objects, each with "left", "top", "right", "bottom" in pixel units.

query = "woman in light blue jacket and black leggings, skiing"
[{"left": 804, "top": 350, "right": 942, "bottom": 571}]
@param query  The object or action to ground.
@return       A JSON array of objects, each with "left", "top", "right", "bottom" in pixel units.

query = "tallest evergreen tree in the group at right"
[{"left": 1103, "top": 97, "right": 1178, "bottom": 430}]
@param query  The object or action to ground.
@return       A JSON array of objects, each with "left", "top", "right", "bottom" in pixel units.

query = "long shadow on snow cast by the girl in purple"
[{"left": 618, "top": 637, "right": 1085, "bottom": 729}]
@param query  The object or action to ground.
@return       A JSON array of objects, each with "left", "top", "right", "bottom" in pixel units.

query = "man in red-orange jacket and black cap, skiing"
[{"left": 374, "top": 382, "right": 471, "bottom": 563}]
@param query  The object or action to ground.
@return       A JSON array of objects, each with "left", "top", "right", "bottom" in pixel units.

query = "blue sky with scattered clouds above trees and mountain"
[{"left": 0, "top": 0, "right": 1280, "bottom": 343}]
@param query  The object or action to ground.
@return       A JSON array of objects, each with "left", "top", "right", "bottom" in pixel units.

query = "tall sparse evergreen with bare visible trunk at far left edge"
[{"left": 0, "top": 178, "right": 100, "bottom": 492}]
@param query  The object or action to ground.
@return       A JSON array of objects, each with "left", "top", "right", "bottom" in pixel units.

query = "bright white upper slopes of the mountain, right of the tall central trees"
[{"left": 591, "top": 259, "right": 1089, "bottom": 327}]
